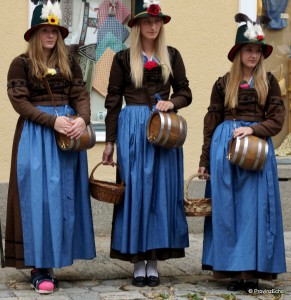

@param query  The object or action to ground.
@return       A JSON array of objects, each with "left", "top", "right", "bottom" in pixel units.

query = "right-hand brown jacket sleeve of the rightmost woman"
[{"left": 251, "top": 73, "right": 286, "bottom": 138}]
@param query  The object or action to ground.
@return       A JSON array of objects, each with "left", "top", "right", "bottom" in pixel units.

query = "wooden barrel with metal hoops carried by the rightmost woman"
[{"left": 228, "top": 135, "right": 269, "bottom": 170}]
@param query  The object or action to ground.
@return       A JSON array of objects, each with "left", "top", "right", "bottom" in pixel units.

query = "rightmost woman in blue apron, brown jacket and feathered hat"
[{"left": 198, "top": 14, "right": 286, "bottom": 291}]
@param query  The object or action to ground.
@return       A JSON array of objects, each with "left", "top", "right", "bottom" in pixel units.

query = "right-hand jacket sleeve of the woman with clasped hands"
[{"left": 69, "top": 57, "right": 91, "bottom": 124}]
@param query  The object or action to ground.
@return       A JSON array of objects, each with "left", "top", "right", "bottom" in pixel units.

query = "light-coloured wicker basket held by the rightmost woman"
[{"left": 184, "top": 173, "right": 211, "bottom": 217}]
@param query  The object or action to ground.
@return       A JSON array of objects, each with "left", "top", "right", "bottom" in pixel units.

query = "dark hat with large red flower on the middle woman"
[{"left": 128, "top": 0, "right": 171, "bottom": 27}]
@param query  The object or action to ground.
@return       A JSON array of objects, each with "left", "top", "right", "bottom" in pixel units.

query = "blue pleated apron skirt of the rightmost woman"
[{"left": 202, "top": 121, "right": 286, "bottom": 273}]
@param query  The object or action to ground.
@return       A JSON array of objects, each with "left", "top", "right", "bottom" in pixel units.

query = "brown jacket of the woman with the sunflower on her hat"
[{"left": 7, "top": 55, "right": 90, "bottom": 128}]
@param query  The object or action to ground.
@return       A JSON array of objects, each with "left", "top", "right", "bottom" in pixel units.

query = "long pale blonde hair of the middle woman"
[{"left": 130, "top": 21, "right": 172, "bottom": 88}]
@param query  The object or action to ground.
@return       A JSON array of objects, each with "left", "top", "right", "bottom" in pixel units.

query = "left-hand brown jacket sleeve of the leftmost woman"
[{"left": 7, "top": 56, "right": 56, "bottom": 128}]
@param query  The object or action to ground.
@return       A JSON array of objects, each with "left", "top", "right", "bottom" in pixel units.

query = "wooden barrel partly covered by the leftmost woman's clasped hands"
[{"left": 55, "top": 116, "right": 96, "bottom": 151}]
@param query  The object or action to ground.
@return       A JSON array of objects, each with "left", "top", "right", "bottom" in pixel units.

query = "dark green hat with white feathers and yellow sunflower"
[{"left": 24, "top": 0, "right": 69, "bottom": 42}]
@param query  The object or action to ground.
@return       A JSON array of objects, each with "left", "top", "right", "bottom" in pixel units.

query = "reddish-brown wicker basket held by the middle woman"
[{"left": 89, "top": 162, "right": 125, "bottom": 205}]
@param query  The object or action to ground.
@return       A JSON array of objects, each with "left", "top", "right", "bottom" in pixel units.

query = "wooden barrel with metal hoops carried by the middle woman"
[{"left": 147, "top": 111, "right": 187, "bottom": 148}]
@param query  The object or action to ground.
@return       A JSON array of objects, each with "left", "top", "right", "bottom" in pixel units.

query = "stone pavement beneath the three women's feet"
[{"left": 0, "top": 231, "right": 291, "bottom": 300}]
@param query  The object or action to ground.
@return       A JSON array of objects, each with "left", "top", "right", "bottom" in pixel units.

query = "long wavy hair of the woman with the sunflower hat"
[{"left": 26, "top": 30, "right": 72, "bottom": 80}]
